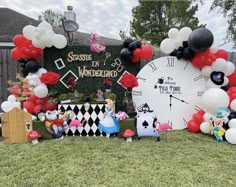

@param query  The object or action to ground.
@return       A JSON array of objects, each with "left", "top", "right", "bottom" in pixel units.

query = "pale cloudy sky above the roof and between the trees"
[{"left": 0, "top": 0, "right": 233, "bottom": 52}]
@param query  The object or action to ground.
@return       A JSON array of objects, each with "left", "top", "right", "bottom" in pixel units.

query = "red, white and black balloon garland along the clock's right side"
[{"left": 160, "top": 27, "right": 236, "bottom": 144}]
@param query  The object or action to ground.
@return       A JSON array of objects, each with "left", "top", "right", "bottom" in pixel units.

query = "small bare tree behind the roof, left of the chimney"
[{"left": 38, "top": 9, "right": 64, "bottom": 26}]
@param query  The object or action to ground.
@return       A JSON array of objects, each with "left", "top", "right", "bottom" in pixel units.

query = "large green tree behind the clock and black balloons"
[{"left": 131, "top": 0, "right": 203, "bottom": 45}]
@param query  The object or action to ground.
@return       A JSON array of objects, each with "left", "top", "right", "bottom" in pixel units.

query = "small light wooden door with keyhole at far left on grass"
[{"left": 2, "top": 108, "right": 32, "bottom": 143}]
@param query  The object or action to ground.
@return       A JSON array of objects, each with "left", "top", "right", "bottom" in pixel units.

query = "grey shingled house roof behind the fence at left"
[{"left": 0, "top": 8, "right": 122, "bottom": 45}]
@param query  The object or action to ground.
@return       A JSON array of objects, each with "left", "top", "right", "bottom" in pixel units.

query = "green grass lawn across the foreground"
[{"left": 0, "top": 127, "right": 236, "bottom": 187}]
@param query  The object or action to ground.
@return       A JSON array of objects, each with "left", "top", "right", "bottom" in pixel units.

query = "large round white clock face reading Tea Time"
[{"left": 132, "top": 56, "right": 206, "bottom": 129}]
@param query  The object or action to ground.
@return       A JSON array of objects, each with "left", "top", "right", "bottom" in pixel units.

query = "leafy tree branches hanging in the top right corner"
[{"left": 210, "top": 0, "right": 236, "bottom": 47}]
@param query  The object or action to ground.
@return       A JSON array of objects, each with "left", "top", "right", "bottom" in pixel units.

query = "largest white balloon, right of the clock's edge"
[{"left": 201, "top": 88, "right": 229, "bottom": 114}]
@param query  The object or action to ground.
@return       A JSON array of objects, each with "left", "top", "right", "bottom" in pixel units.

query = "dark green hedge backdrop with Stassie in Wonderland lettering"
[{"left": 44, "top": 46, "right": 140, "bottom": 110}]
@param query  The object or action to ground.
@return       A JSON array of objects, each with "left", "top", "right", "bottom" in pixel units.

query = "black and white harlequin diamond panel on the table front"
[{"left": 58, "top": 104, "right": 105, "bottom": 136}]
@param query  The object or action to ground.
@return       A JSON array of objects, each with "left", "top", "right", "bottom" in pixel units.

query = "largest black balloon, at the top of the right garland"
[{"left": 188, "top": 28, "right": 214, "bottom": 52}]
